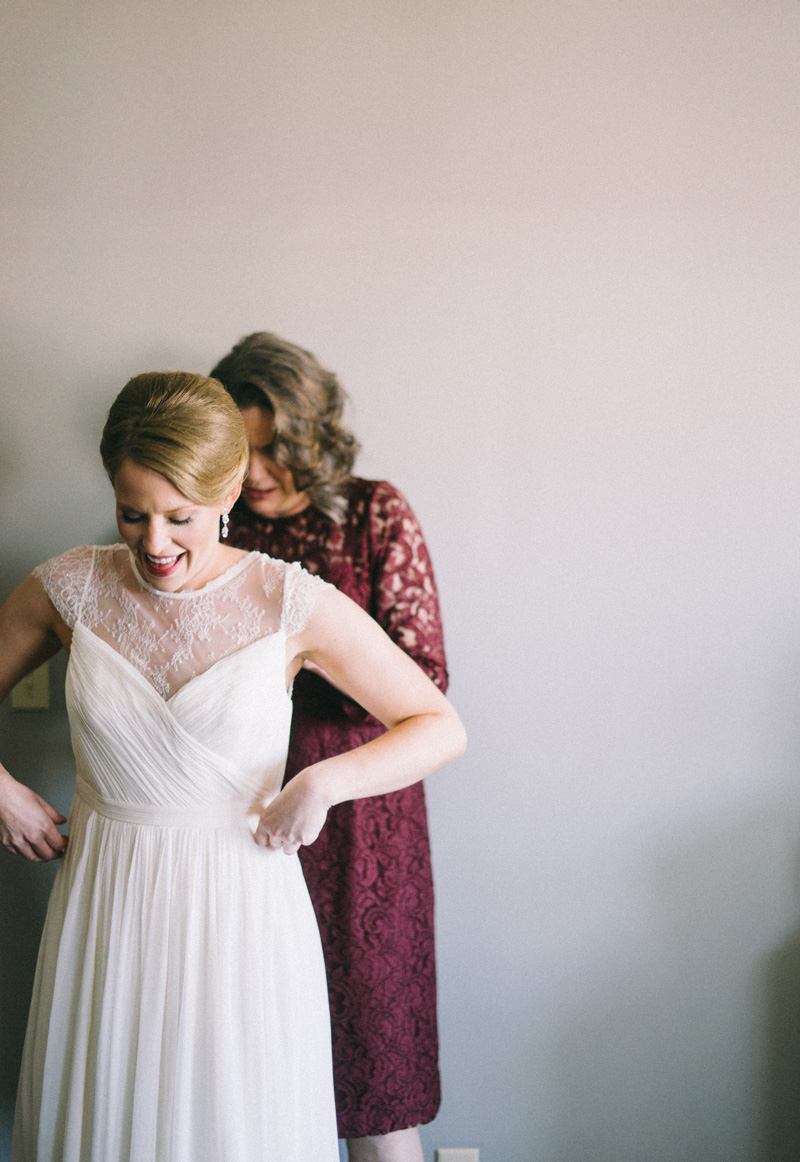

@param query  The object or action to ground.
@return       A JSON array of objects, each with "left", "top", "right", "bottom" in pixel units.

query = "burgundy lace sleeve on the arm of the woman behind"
[{"left": 370, "top": 483, "right": 448, "bottom": 690}]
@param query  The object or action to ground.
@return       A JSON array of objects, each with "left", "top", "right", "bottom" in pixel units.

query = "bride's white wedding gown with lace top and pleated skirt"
[{"left": 12, "top": 546, "right": 338, "bottom": 1162}]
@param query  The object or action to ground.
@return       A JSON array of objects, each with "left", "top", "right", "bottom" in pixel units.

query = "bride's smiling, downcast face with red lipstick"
[{"left": 114, "top": 460, "right": 238, "bottom": 593}]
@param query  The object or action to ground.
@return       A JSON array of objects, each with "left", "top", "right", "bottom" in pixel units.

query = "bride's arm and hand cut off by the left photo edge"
[{"left": 0, "top": 578, "right": 66, "bottom": 862}]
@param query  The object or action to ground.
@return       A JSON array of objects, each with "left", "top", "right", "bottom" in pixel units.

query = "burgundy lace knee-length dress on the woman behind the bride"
[{"left": 228, "top": 478, "right": 447, "bottom": 1138}]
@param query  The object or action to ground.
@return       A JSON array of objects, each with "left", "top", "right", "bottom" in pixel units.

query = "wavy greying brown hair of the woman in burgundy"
[{"left": 212, "top": 331, "right": 359, "bottom": 524}]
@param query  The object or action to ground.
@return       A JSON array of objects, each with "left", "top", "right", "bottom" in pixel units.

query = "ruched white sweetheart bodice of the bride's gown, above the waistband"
[{"left": 66, "top": 624, "right": 292, "bottom": 816}]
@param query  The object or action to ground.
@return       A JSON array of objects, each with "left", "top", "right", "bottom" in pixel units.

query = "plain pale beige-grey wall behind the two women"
[{"left": 0, "top": 0, "right": 800, "bottom": 1162}]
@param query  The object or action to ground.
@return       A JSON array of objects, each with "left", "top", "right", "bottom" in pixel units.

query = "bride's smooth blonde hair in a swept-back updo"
[{"left": 100, "top": 371, "right": 249, "bottom": 505}]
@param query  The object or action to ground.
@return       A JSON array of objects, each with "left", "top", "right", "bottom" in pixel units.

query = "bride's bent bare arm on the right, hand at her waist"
[{"left": 256, "top": 589, "right": 466, "bottom": 851}]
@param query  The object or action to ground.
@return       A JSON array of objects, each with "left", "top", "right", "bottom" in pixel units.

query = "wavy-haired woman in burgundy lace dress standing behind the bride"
[{"left": 212, "top": 332, "right": 447, "bottom": 1162}]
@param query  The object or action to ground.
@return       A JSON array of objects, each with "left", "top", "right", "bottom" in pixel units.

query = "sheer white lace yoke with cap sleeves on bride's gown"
[{"left": 34, "top": 545, "right": 324, "bottom": 698}]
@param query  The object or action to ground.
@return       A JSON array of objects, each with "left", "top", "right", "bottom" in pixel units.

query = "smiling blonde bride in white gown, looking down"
[{"left": 0, "top": 372, "right": 464, "bottom": 1162}]
